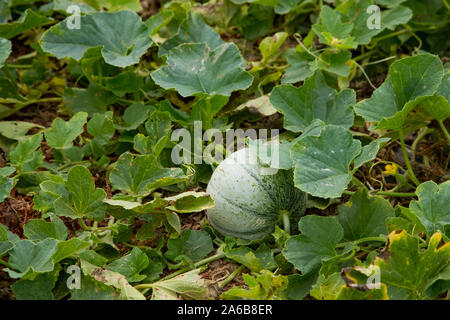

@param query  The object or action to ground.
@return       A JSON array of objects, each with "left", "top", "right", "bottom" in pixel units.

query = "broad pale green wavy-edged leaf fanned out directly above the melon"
[{"left": 151, "top": 43, "right": 253, "bottom": 97}]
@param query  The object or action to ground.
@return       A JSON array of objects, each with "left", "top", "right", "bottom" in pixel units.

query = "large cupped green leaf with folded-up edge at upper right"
[{"left": 354, "top": 54, "right": 444, "bottom": 129}]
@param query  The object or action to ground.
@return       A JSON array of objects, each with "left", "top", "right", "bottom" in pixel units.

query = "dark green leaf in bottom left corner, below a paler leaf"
[{"left": 11, "top": 265, "right": 61, "bottom": 300}]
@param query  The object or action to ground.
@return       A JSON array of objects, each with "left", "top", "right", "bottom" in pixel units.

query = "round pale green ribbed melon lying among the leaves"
[{"left": 206, "top": 148, "right": 306, "bottom": 240}]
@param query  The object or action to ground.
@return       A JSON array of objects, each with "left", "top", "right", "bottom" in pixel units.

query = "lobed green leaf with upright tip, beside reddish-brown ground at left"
[{"left": 55, "top": 166, "right": 106, "bottom": 221}]
